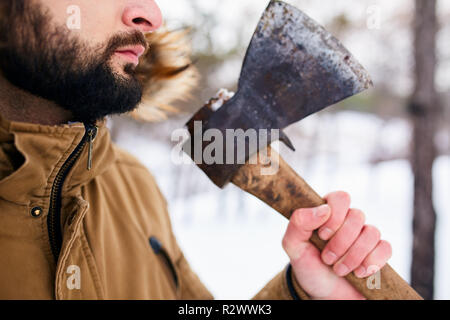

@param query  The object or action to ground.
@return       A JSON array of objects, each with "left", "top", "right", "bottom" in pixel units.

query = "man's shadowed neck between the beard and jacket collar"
[{"left": 0, "top": 75, "right": 71, "bottom": 125}]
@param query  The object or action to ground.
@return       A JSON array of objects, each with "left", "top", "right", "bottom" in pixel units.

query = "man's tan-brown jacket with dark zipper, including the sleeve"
[{"left": 0, "top": 114, "right": 308, "bottom": 299}]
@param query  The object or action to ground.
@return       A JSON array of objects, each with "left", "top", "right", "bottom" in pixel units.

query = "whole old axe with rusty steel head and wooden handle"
[{"left": 183, "top": 0, "right": 422, "bottom": 300}]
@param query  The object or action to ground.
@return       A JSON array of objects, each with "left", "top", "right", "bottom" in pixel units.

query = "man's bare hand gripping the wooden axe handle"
[{"left": 283, "top": 192, "right": 392, "bottom": 300}]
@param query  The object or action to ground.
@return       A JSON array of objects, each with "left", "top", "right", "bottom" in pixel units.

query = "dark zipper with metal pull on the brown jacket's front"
[{"left": 47, "top": 124, "right": 98, "bottom": 263}]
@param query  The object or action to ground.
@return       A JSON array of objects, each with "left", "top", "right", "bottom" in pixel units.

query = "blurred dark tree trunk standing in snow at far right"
[{"left": 409, "top": 0, "right": 440, "bottom": 299}]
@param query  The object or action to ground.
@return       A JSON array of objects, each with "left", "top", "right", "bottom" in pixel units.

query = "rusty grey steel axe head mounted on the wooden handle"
[{"left": 185, "top": 1, "right": 372, "bottom": 187}]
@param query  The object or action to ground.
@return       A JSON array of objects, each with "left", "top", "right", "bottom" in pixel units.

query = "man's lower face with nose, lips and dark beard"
[{"left": 0, "top": 0, "right": 162, "bottom": 123}]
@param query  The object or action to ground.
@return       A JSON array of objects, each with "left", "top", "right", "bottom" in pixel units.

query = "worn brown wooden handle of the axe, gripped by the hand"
[{"left": 232, "top": 147, "right": 422, "bottom": 300}]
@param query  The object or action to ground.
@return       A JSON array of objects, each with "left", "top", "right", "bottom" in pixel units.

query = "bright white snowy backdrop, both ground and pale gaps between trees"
[{"left": 115, "top": 0, "right": 450, "bottom": 299}]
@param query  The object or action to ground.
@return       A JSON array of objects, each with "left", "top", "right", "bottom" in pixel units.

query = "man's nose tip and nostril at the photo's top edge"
[{"left": 122, "top": 0, "right": 163, "bottom": 33}]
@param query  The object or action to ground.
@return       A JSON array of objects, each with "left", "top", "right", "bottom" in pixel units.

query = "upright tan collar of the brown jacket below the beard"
[{"left": 0, "top": 115, "right": 115, "bottom": 206}]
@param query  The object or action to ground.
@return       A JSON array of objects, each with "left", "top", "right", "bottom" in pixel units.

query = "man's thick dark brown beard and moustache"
[{"left": 0, "top": 0, "right": 147, "bottom": 122}]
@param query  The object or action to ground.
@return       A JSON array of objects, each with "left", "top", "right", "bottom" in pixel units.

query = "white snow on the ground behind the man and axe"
[{"left": 115, "top": 112, "right": 450, "bottom": 299}]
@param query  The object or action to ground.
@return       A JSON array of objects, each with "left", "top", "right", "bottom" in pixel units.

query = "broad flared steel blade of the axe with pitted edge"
[{"left": 234, "top": 1, "right": 372, "bottom": 129}]
